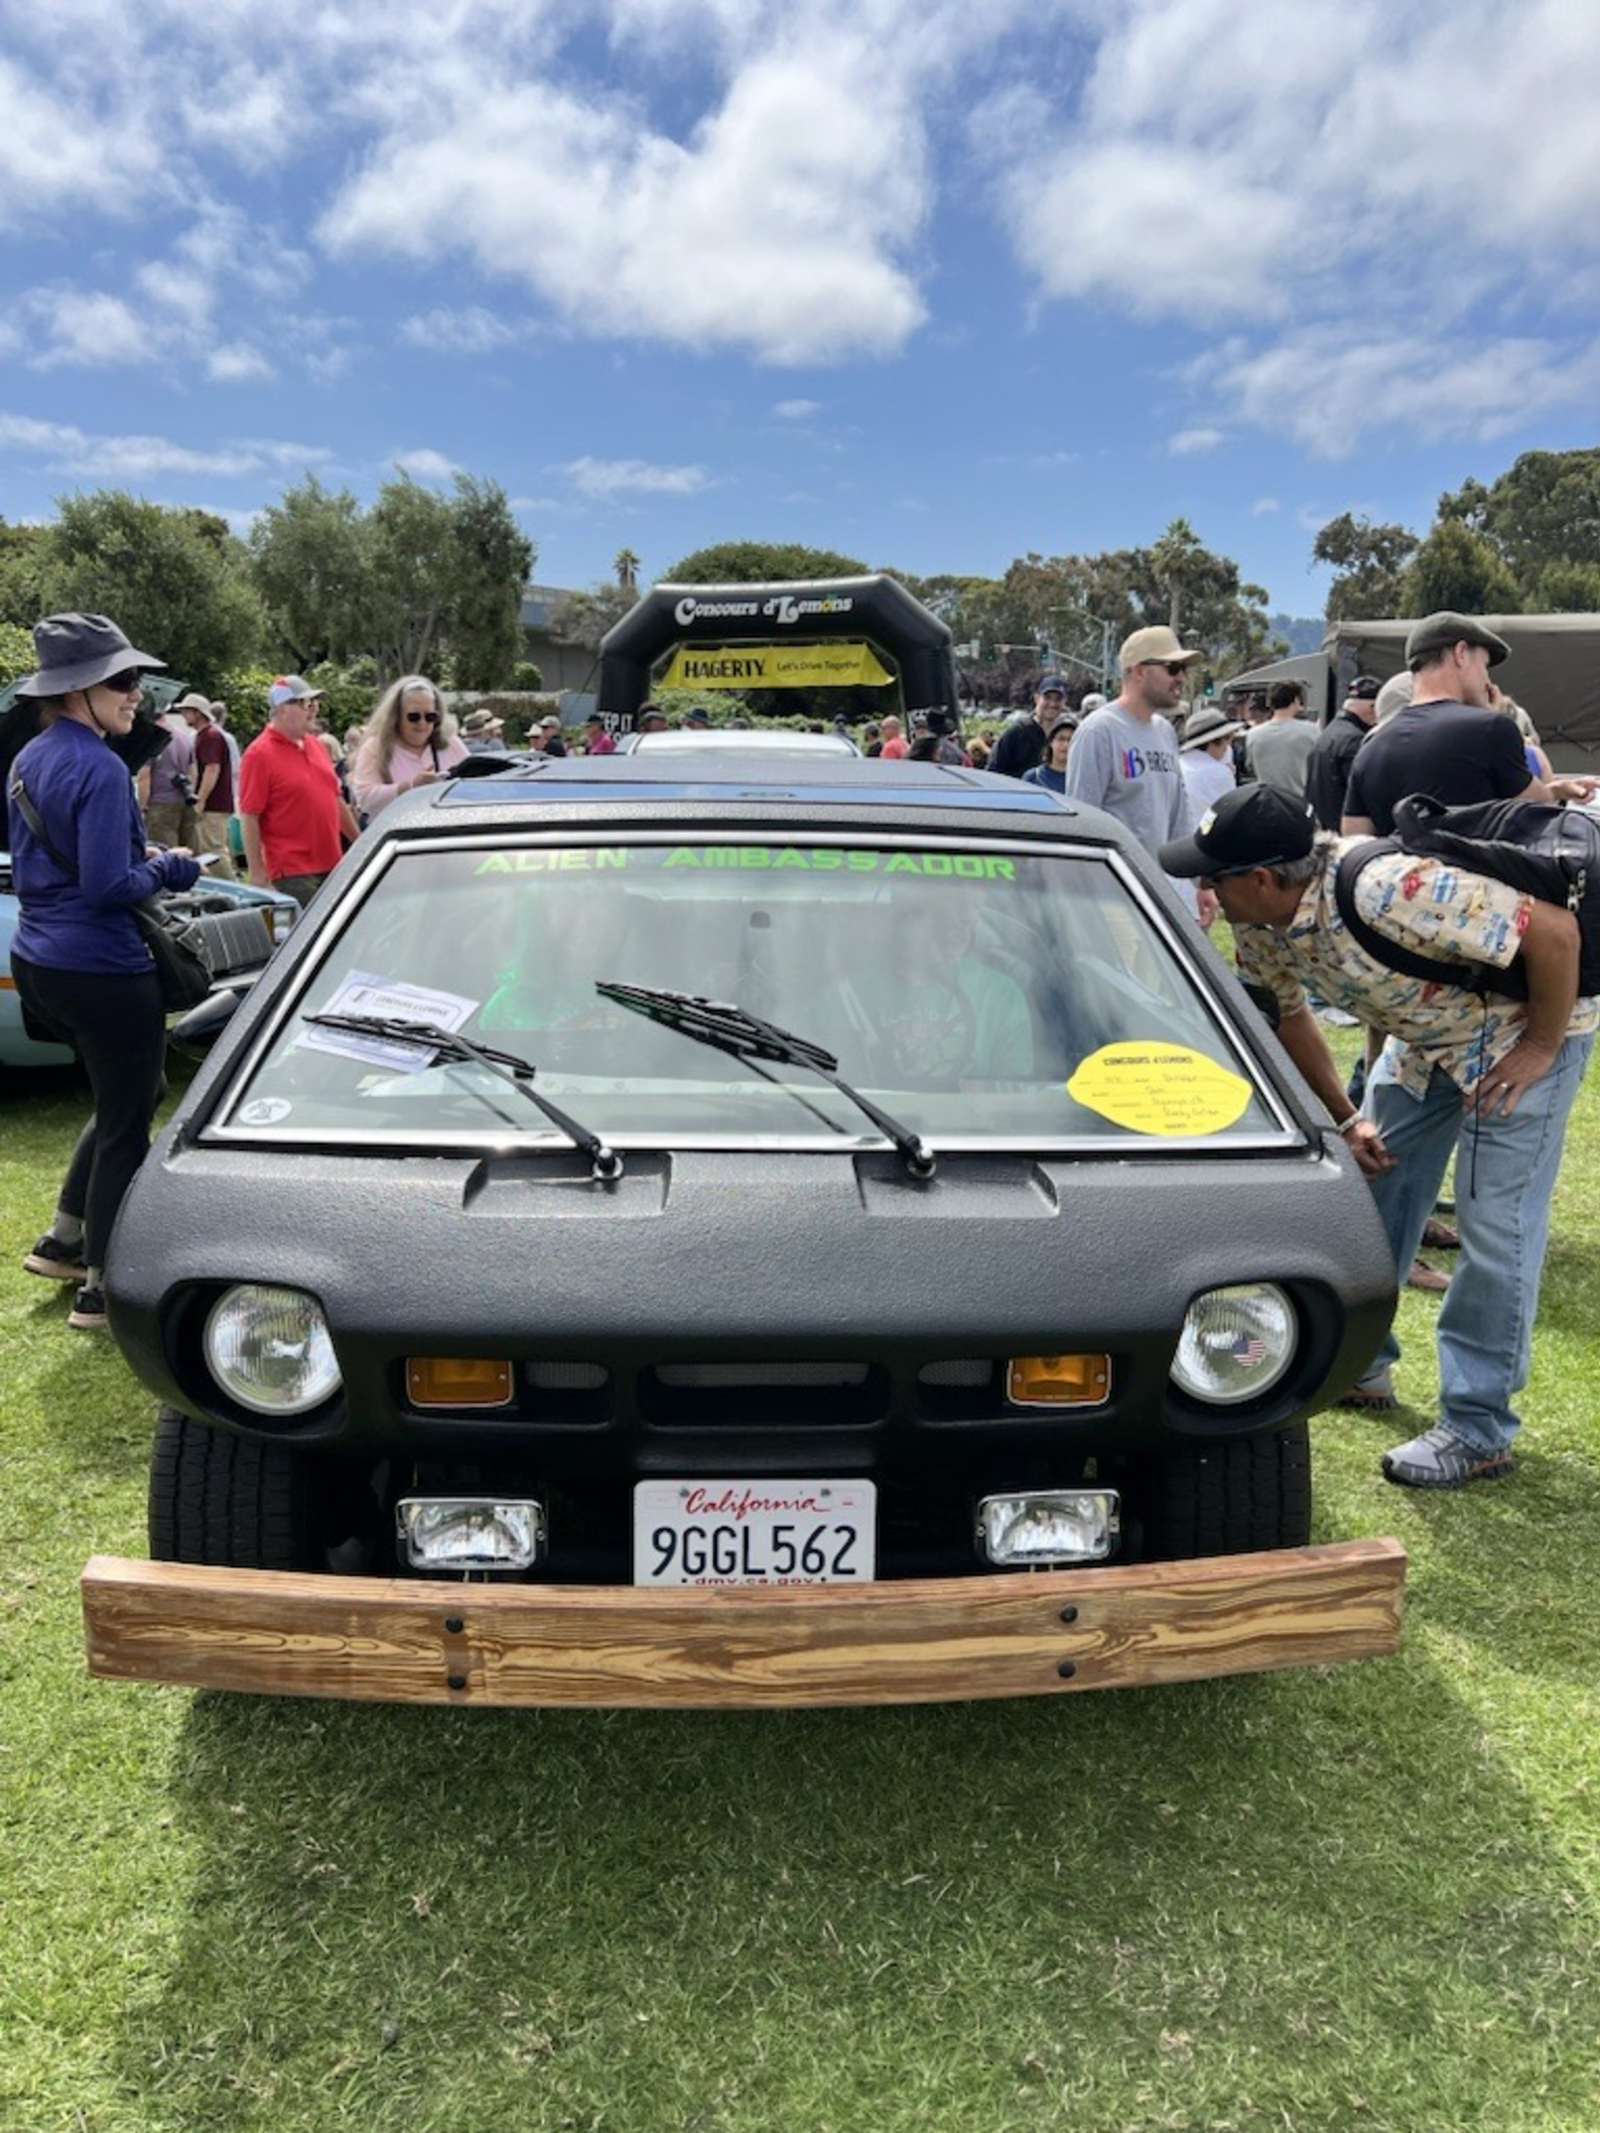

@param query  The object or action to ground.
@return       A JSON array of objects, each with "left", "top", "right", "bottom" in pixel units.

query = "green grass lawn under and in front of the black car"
[{"left": 0, "top": 1057, "right": 1600, "bottom": 2133}]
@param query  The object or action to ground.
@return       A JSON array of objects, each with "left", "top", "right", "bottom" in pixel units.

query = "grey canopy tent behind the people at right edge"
[{"left": 1220, "top": 614, "right": 1600, "bottom": 772}]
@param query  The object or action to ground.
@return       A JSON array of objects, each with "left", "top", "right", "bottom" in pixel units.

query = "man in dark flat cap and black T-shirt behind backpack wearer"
[{"left": 1340, "top": 610, "right": 1600, "bottom": 836}]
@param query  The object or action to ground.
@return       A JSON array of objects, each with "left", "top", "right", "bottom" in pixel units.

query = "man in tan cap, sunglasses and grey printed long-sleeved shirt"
[{"left": 1065, "top": 625, "right": 1216, "bottom": 926}]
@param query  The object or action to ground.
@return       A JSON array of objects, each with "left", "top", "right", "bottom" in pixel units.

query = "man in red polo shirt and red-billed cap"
[{"left": 239, "top": 674, "right": 361, "bottom": 904}]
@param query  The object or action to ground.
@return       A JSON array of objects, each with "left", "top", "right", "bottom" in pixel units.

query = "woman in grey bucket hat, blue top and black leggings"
[{"left": 9, "top": 614, "right": 201, "bottom": 1329}]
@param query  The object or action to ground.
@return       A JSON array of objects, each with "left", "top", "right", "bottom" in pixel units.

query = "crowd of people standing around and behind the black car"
[{"left": 9, "top": 614, "right": 1600, "bottom": 1489}]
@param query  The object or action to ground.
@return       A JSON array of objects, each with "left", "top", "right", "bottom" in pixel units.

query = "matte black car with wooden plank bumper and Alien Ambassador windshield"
[{"left": 92, "top": 749, "right": 1397, "bottom": 1702}]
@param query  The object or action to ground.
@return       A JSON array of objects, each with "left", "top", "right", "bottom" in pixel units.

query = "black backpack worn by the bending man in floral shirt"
[{"left": 1333, "top": 793, "right": 1600, "bottom": 1000}]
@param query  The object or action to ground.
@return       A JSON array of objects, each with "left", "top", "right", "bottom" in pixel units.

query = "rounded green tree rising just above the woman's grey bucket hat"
[{"left": 38, "top": 488, "right": 262, "bottom": 689}]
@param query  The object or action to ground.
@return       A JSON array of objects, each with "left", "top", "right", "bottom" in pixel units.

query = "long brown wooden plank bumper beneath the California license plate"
[{"left": 81, "top": 1540, "right": 1406, "bottom": 1709}]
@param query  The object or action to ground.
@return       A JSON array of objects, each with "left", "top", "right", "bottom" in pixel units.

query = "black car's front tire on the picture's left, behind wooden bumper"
[{"left": 149, "top": 1408, "right": 322, "bottom": 1570}]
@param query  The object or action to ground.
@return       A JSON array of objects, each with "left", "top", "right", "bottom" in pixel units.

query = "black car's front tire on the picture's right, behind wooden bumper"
[{"left": 1146, "top": 1423, "right": 1312, "bottom": 1561}]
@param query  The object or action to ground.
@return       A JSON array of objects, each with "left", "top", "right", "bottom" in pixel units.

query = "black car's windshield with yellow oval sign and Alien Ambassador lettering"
[{"left": 213, "top": 834, "right": 1284, "bottom": 1148}]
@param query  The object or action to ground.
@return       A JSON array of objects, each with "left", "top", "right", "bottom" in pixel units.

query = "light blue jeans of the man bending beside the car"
[{"left": 1365, "top": 1035, "right": 1594, "bottom": 1453}]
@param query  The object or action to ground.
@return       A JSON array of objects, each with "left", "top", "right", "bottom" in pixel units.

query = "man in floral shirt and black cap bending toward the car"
[{"left": 1161, "top": 785, "right": 1600, "bottom": 1489}]
